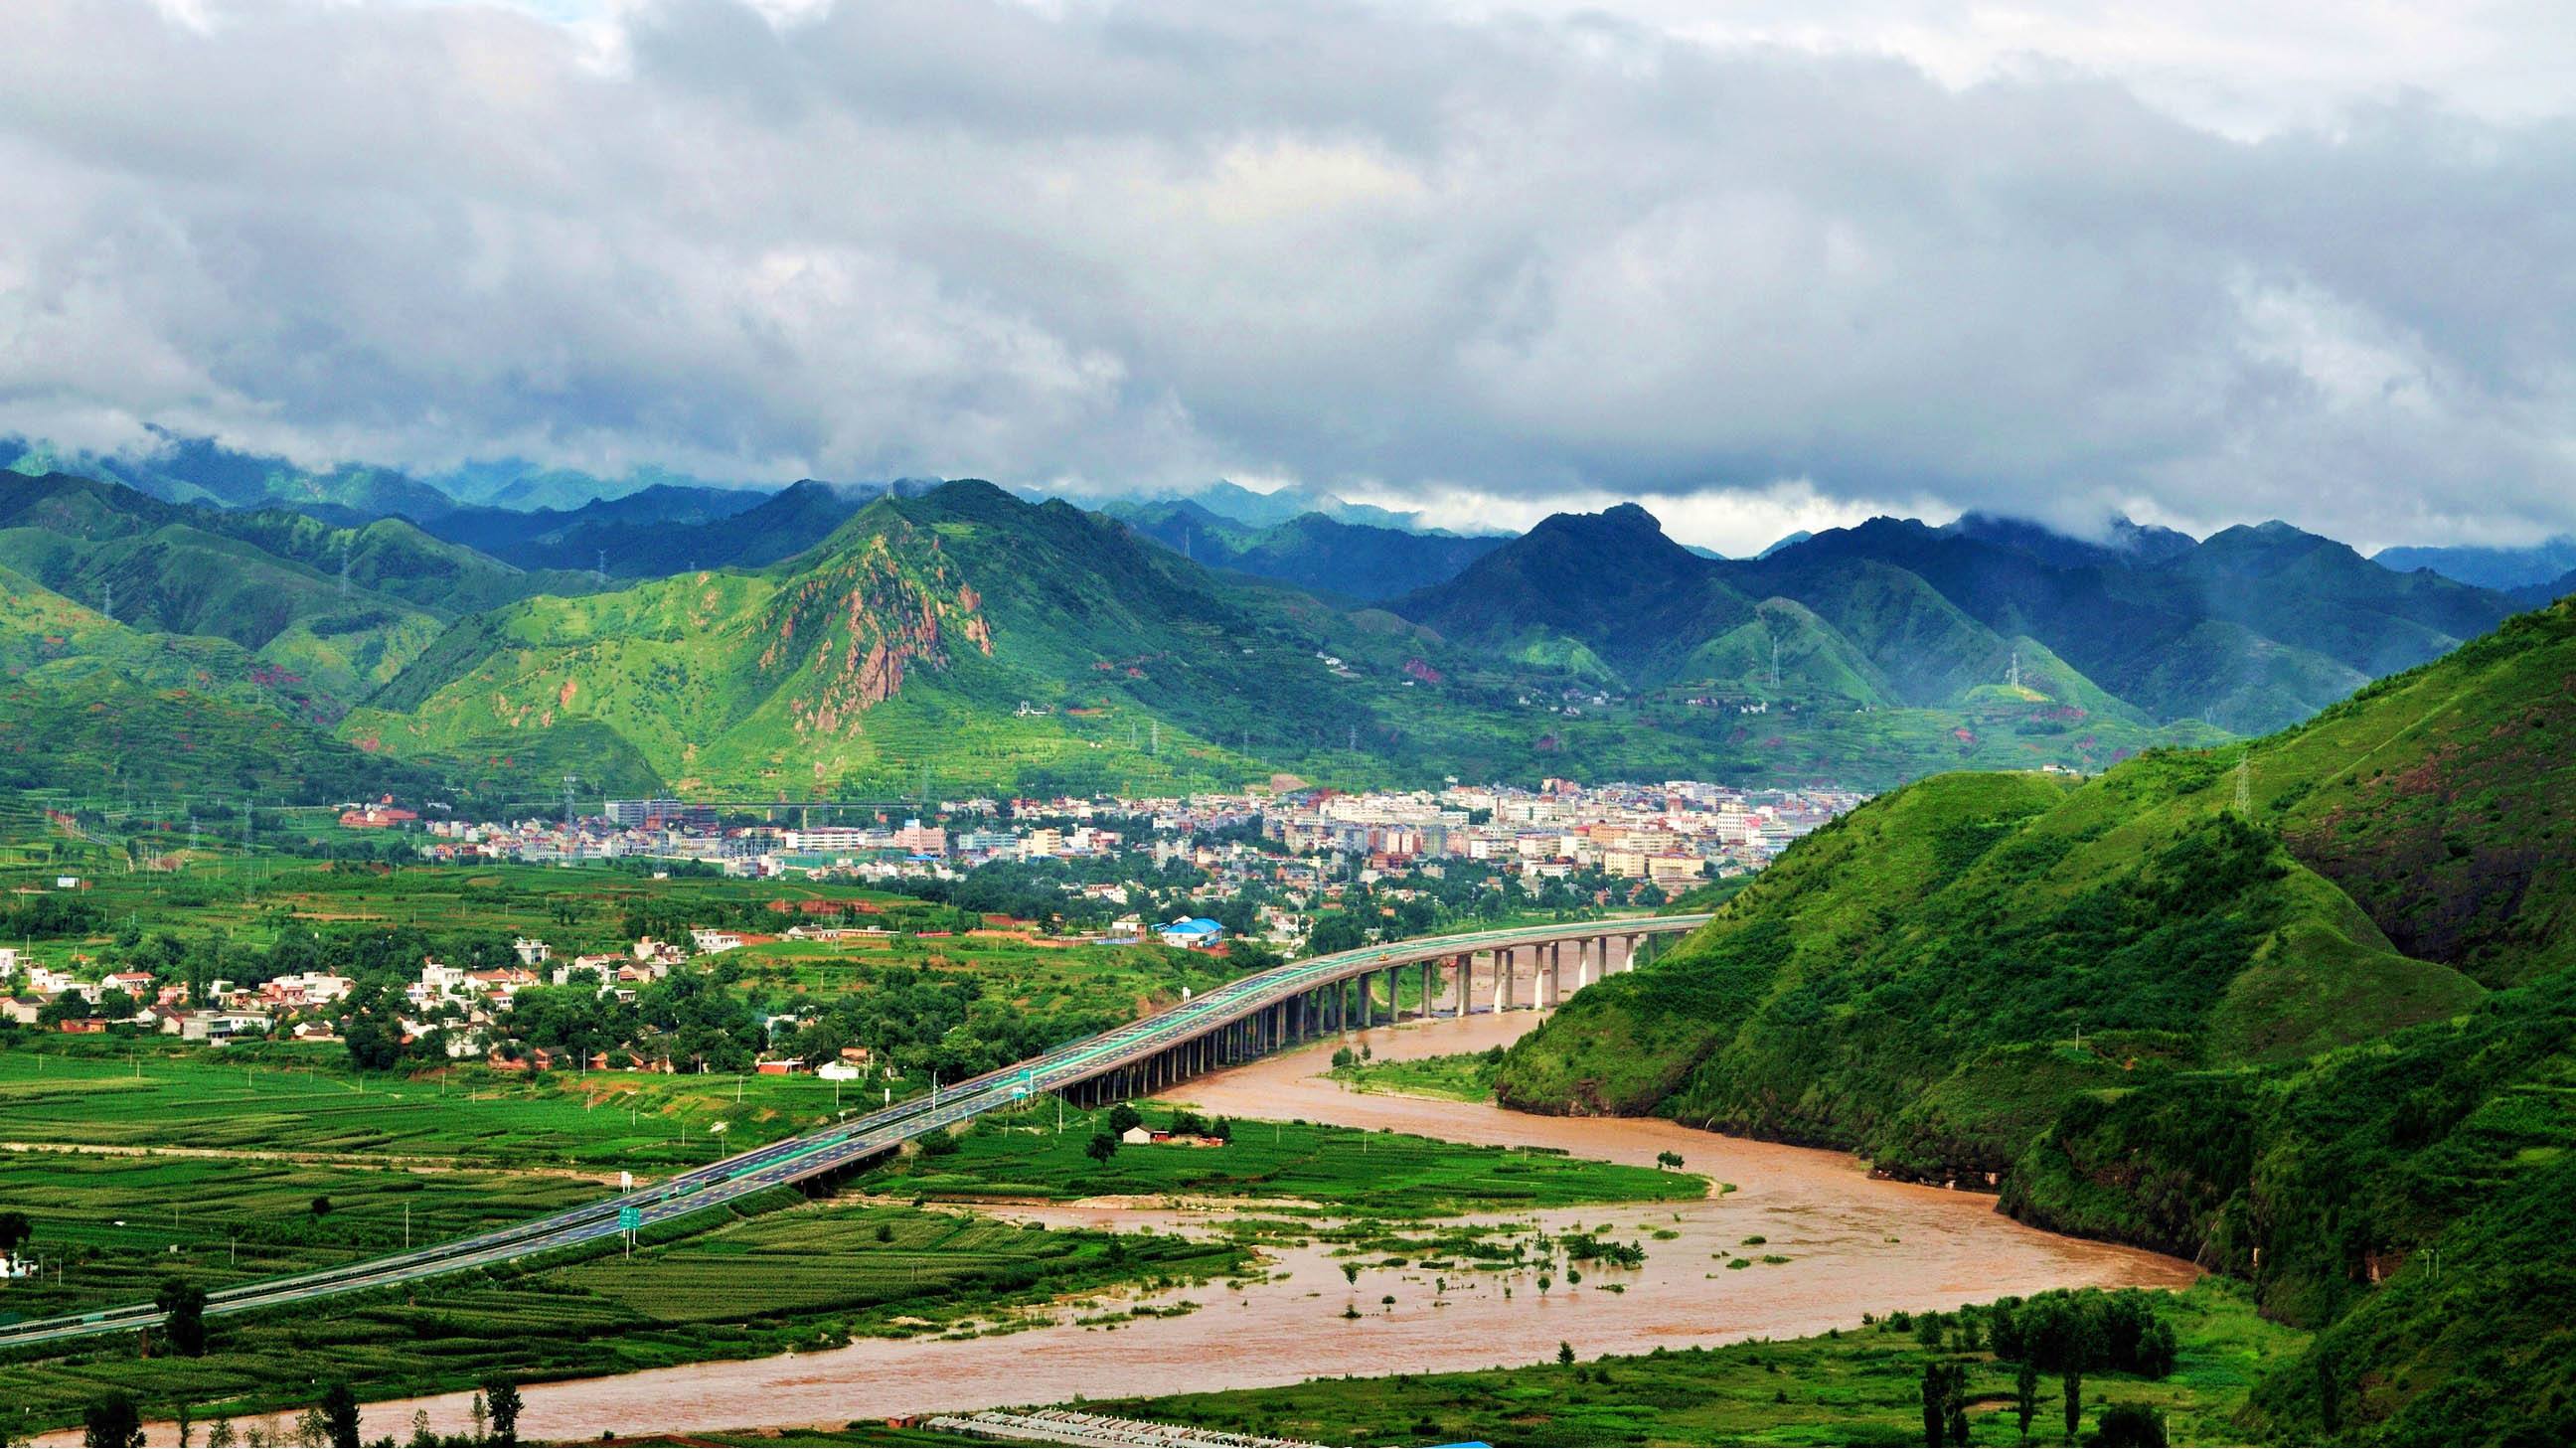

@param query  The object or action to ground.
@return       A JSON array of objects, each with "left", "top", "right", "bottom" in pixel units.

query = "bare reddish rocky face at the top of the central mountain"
[{"left": 760, "top": 515, "right": 992, "bottom": 734}]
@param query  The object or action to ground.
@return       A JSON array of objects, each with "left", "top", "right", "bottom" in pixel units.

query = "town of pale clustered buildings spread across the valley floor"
[{"left": 0, "top": 778, "right": 1865, "bottom": 1075}]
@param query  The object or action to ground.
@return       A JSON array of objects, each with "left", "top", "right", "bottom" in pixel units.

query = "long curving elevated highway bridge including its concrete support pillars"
[{"left": 0, "top": 915, "right": 1707, "bottom": 1349}]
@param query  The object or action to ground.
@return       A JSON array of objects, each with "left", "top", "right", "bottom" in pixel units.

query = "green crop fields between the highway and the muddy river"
[{"left": 0, "top": 1192, "right": 1244, "bottom": 1439}]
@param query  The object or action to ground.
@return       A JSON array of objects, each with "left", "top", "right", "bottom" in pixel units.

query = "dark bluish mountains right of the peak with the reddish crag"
[{"left": 1388, "top": 503, "right": 2516, "bottom": 732}]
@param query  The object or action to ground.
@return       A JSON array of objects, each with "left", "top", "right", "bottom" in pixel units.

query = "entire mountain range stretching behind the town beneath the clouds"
[{"left": 0, "top": 432, "right": 2565, "bottom": 799}]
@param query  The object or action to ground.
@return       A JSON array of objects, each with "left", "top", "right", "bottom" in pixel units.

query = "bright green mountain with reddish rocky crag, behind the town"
[{"left": 343, "top": 482, "right": 2235, "bottom": 799}]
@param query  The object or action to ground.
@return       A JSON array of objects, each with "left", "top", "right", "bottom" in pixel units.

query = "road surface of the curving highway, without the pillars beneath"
[{"left": 0, "top": 915, "right": 1707, "bottom": 1349}]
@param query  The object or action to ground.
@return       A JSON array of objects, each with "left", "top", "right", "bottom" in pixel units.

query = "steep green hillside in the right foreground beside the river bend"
[{"left": 1502, "top": 600, "right": 2576, "bottom": 1441}]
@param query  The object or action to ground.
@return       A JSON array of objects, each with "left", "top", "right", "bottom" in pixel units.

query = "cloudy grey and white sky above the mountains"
[{"left": 0, "top": 0, "right": 2576, "bottom": 550}]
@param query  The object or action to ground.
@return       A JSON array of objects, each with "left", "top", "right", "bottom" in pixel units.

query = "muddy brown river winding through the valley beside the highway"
[{"left": 327, "top": 1014, "right": 2194, "bottom": 1441}]
